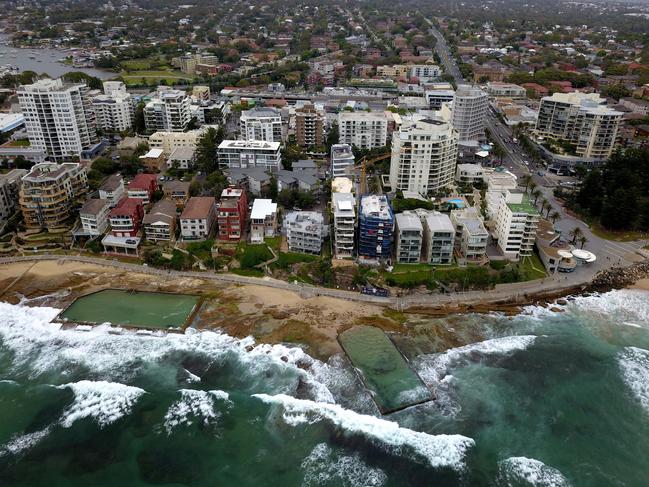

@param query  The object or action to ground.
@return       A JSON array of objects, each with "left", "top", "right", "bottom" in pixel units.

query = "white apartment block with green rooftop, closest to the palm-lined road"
[{"left": 487, "top": 191, "right": 540, "bottom": 260}]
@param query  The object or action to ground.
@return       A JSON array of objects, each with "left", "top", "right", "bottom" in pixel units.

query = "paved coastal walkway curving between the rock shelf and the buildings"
[{"left": 0, "top": 254, "right": 593, "bottom": 311}]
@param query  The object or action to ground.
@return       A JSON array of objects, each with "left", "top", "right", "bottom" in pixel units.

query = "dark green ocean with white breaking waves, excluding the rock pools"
[{"left": 0, "top": 290, "right": 649, "bottom": 487}]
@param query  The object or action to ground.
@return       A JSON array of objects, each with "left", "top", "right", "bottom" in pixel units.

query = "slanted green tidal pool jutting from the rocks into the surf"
[{"left": 338, "top": 326, "right": 432, "bottom": 414}]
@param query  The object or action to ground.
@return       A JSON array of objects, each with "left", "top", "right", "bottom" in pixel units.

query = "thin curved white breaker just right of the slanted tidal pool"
[{"left": 413, "top": 335, "right": 537, "bottom": 385}]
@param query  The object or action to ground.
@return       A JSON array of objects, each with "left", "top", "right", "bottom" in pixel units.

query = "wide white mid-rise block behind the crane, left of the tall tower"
[{"left": 338, "top": 111, "right": 388, "bottom": 149}]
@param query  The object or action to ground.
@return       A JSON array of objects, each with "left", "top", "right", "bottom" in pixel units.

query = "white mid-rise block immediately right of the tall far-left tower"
[{"left": 92, "top": 81, "right": 135, "bottom": 132}]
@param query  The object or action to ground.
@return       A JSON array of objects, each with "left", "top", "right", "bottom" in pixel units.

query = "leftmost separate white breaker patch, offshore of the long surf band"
[{"left": 58, "top": 380, "right": 145, "bottom": 428}]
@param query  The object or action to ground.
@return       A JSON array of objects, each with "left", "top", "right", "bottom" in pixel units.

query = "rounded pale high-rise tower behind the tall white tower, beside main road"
[{"left": 451, "top": 85, "right": 489, "bottom": 143}]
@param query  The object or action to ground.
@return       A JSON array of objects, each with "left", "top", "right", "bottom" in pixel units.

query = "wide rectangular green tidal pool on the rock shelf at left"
[{"left": 60, "top": 289, "right": 198, "bottom": 328}]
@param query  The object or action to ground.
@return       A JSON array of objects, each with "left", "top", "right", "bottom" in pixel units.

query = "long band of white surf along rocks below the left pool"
[{"left": 0, "top": 303, "right": 344, "bottom": 402}]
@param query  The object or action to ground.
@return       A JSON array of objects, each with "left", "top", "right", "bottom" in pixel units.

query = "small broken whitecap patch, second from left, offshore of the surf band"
[{"left": 164, "top": 389, "right": 230, "bottom": 434}]
